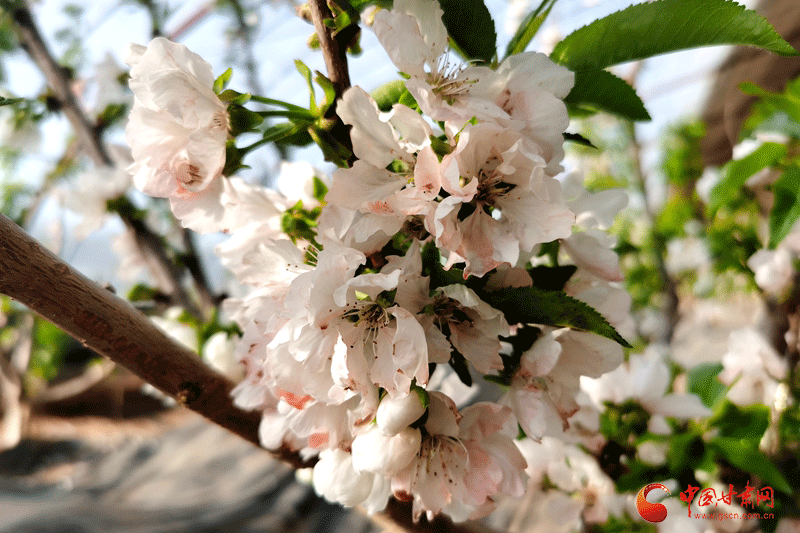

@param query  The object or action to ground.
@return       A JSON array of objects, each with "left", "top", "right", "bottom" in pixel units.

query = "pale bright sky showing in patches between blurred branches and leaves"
[{"left": 0, "top": 0, "right": 754, "bottom": 288}]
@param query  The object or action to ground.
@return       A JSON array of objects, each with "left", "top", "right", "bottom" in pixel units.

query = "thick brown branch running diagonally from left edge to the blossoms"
[{"left": 0, "top": 215, "right": 304, "bottom": 466}]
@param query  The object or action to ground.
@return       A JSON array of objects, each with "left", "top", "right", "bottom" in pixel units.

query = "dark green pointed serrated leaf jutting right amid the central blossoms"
[{"left": 480, "top": 287, "right": 630, "bottom": 348}]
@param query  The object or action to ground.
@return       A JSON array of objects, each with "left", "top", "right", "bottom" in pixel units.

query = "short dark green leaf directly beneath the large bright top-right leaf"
[{"left": 564, "top": 70, "right": 650, "bottom": 121}]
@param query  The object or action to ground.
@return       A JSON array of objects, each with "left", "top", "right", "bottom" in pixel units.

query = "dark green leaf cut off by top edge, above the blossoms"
[{"left": 439, "top": 0, "right": 497, "bottom": 63}]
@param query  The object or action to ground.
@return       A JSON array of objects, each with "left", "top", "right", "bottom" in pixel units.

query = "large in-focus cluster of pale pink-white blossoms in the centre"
[{"left": 127, "top": 0, "right": 630, "bottom": 520}]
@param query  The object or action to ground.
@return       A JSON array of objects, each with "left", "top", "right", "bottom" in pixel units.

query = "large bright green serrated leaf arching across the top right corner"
[{"left": 550, "top": 0, "right": 797, "bottom": 71}]
